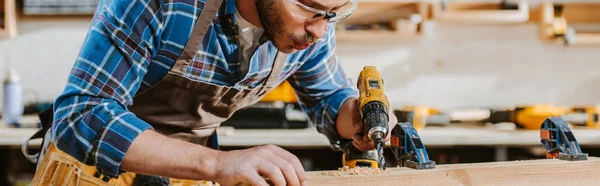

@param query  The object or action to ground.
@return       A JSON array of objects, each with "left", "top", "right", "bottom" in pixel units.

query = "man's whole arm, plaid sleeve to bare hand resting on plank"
[{"left": 52, "top": 0, "right": 306, "bottom": 185}]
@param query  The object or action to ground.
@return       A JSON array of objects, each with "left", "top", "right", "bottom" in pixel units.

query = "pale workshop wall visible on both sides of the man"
[{"left": 0, "top": 19, "right": 600, "bottom": 108}]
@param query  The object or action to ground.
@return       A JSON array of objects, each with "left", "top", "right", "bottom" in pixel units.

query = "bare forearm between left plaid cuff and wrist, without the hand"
[{"left": 121, "top": 130, "right": 218, "bottom": 180}]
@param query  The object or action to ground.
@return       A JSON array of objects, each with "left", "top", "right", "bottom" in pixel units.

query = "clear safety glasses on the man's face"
[{"left": 283, "top": 0, "right": 358, "bottom": 23}]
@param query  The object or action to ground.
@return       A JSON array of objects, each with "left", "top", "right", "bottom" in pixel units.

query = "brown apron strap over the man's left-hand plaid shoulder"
[{"left": 172, "top": 0, "right": 223, "bottom": 74}]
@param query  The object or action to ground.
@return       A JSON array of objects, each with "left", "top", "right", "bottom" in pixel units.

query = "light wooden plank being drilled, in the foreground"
[{"left": 307, "top": 157, "right": 600, "bottom": 186}]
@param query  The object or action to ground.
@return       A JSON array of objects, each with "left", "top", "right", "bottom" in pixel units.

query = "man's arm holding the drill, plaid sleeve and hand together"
[{"left": 288, "top": 25, "right": 397, "bottom": 150}]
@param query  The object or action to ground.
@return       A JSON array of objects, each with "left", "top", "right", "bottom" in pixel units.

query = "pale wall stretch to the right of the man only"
[{"left": 338, "top": 24, "right": 600, "bottom": 108}]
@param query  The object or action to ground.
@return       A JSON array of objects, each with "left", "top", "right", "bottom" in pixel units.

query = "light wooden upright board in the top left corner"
[{"left": 0, "top": 0, "right": 17, "bottom": 39}]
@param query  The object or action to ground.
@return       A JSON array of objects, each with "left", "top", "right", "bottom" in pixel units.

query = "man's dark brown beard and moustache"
[{"left": 256, "top": 0, "right": 316, "bottom": 53}]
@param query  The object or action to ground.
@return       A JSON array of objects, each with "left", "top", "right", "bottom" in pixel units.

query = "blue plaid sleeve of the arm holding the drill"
[{"left": 288, "top": 24, "right": 358, "bottom": 145}]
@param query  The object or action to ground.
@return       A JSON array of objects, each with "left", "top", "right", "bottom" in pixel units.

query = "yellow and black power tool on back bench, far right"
[{"left": 490, "top": 104, "right": 598, "bottom": 130}]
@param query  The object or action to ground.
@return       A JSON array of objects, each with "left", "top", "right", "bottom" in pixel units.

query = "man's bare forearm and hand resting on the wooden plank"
[{"left": 121, "top": 130, "right": 306, "bottom": 186}]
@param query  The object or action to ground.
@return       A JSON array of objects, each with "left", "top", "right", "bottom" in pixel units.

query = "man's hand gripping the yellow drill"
[{"left": 336, "top": 98, "right": 398, "bottom": 151}]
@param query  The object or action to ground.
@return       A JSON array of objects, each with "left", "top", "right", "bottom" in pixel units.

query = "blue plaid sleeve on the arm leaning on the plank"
[{"left": 52, "top": 0, "right": 163, "bottom": 178}]
